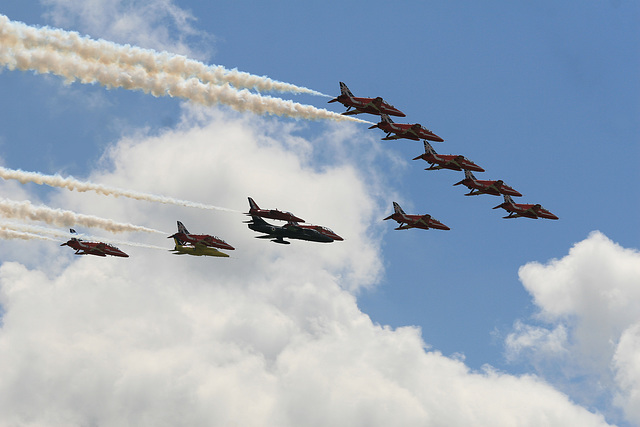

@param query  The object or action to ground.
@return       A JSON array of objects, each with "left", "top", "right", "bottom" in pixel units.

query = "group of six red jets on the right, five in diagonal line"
[{"left": 329, "top": 82, "right": 558, "bottom": 230}]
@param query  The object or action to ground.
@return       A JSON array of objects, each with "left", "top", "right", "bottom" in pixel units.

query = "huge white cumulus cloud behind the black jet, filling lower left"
[{"left": 0, "top": 109, "right": 612, "bottom": 426}]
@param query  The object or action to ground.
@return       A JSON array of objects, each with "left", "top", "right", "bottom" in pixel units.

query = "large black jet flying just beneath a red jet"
[{"left": 247, "top": 215, "right": 344, "bottom": 245}]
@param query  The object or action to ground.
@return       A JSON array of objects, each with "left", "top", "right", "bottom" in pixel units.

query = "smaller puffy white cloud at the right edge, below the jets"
[{"left": 506, "top": 232, "right": 640, "bottom": 424}]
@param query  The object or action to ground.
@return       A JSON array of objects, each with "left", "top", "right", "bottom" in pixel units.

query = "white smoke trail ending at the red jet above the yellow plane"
[{"left": 0, "top": 199, "right": 168, "bottom": 234}]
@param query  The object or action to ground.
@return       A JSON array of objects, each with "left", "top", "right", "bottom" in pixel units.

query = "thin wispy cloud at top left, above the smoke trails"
[{"left": 41, "top": 0, "right": 212, "bottom": 58}]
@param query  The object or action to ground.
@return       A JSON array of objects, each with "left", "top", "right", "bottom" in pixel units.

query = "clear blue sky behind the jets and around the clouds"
[{"left": 0, "top": 0, "right": 640, "bottom": 425}]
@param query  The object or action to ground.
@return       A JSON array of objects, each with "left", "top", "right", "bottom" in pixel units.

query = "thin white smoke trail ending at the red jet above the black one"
[{"left": 0, "top": 166, "right": 241, "bottom": 213}]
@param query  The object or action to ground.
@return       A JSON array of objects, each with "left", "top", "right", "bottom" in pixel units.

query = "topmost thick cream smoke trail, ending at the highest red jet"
[{"left": 0, "top": 15, "right": 329, "bottom": 97}]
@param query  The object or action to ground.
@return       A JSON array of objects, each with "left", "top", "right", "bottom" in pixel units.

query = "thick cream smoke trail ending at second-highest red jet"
[{"left": 0, "top": 44, "right": 371, "bottom": 124}]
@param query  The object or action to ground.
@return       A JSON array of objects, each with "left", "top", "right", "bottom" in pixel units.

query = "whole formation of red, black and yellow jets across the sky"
[{"left": 50, "top": 82, "right": 558, "bottom": 257}]
